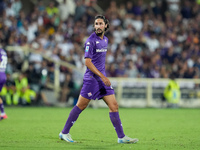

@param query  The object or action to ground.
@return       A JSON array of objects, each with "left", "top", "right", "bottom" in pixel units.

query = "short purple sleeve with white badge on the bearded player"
[{"left": 85, "top": 40, "right": 95, "bottom": 59}]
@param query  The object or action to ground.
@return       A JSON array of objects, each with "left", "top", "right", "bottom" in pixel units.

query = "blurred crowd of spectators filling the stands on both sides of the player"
[{"left": 0, "top": 0, "right": 200, "bottom": 103}]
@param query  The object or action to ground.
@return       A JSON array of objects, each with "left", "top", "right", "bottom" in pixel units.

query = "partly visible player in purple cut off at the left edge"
[{"left": 0, "top": 48, "right": 7, "bottom": 120}]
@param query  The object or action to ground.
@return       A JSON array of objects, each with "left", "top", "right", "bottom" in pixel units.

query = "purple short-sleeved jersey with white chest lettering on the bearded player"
[{"left": 84, "top": 32, "right": 108, "bottom": 80}]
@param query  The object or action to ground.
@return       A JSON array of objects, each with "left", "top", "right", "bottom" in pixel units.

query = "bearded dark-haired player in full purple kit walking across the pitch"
[{"left": 59, "top": 15, "right": 138, "bottom": 143}]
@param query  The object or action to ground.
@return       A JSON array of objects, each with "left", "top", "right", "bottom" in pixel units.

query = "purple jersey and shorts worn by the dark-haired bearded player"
[{"left": 81, "top": 32, "right": 114, "bottom": 100}]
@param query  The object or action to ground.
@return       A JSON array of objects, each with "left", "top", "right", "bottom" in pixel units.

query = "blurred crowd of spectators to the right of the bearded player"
[{"left": 105, "top": 0, "right": 200, "bottom": 78}]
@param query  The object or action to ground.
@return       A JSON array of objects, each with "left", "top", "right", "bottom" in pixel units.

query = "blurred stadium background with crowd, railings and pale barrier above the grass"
[{"left": 0, "top": 0, "right": 200, "bottom": 108}]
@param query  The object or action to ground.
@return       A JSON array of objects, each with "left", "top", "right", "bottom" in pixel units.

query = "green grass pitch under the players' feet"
[{"left": 0, "top": 107, "right": 200, "bottom": 150}]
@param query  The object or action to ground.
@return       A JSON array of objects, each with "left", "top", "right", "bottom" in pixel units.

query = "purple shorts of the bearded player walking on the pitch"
[{"left": 80, "top": 78, "right": 115, "bottom": 100}]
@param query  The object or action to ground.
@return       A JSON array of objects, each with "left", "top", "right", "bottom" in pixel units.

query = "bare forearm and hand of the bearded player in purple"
[{"left": 85, "top": 58, "right": 111, "bottom": 86}]
